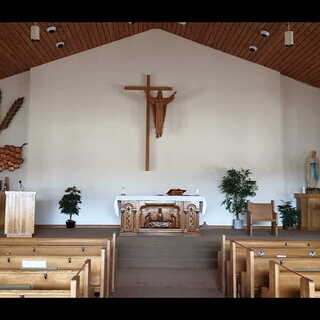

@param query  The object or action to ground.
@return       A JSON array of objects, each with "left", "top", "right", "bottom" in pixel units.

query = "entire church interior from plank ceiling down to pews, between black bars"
[{"left": 0, "top": 21, "right": 320, "bottom": 301}]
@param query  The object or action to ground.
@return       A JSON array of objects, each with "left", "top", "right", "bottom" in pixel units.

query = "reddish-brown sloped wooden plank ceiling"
[{"left": 0, "top": 22, "right": 320, "bottom": 88}]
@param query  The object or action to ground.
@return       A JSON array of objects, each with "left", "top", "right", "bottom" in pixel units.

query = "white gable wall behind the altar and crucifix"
[{"left": 0, "top": 30, "right": 320, "bottom": 225}]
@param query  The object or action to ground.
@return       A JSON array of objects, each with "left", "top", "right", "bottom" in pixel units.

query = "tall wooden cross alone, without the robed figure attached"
[{"left": 124, "top": 74, "right": 173, "bottom": 171}]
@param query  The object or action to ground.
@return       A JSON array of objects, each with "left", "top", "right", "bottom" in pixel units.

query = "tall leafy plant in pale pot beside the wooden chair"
[{"left": 219, "top": 169, "right": 258, "bottom": 229}]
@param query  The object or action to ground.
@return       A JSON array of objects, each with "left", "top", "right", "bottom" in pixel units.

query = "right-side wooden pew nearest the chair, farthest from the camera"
[{"left": 218, "top": 235, "right": 320, "bottom": 297}]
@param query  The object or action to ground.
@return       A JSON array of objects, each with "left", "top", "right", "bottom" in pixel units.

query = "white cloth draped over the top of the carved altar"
[{"left": 114, "top": 195, "right": 207, "bottom": 216}]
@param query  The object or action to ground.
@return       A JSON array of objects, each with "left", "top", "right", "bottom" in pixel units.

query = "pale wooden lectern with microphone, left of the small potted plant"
[{"left": 4, "top": 191, "right": 36, "bottom": 237}]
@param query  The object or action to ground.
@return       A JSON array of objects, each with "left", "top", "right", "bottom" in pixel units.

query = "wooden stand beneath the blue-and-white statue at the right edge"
[{"left": 294, "top": 193, "right": 320, "bottom": 231}]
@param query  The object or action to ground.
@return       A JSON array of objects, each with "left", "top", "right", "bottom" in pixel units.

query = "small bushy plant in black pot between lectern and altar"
[{"left": 59, "top": 187, "right": 81, "bottom": 228}]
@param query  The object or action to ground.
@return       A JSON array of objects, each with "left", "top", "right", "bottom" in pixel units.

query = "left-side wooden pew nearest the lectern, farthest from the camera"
[{"left": 0, "top": 233, "right": 117, "bottom": 297}]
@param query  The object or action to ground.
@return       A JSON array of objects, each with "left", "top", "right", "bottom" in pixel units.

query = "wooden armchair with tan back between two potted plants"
[{"left": 247, "top": 200, "right": 278, "bottom": 236}]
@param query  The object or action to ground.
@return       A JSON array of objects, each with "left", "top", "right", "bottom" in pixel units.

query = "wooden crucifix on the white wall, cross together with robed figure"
[{"left": 124, "top": 74, "right": 176, "bottom": 171}]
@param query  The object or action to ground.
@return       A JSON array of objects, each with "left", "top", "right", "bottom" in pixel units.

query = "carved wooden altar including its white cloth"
[{"left": 115, "top": 196, "right": 205, "bottom": 235}]
